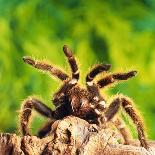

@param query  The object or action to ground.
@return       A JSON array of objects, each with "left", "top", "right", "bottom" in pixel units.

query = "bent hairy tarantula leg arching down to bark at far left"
[{"left": 20, "top": 97, "right": 54, "bottom": 135}]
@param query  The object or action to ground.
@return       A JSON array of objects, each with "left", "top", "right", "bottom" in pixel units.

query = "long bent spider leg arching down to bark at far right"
[{"left": 100, "top": 95, "right": 148, "bottom": 149}]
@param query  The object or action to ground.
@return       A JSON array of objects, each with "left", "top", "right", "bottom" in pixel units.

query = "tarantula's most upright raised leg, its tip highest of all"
[{"left": 63, "top": 45, "right": 79, "bottom": 82}]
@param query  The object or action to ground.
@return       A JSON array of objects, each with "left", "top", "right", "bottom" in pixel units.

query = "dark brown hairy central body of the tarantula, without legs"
[{"left": 53, "top": 84, "right": 101, "bottom": 122}]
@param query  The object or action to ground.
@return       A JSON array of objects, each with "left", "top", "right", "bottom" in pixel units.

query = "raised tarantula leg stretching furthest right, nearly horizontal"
[{"left": 97, "top": 71, "right": 137, "bottom": 88}]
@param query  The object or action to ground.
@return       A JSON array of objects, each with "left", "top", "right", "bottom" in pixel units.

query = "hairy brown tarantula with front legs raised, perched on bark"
[{"left": 20, "top": 45, "right": 148, "bottom": 149}]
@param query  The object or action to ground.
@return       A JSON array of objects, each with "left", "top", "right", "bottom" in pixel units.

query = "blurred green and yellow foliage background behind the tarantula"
[{"left": 0, "top": 0, "right": 155, "bottom": 139}]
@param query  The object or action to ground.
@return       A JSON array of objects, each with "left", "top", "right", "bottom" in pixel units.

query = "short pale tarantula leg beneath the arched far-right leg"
[{"left": 113, "top": 118, "right": 131, "bottom": 145}]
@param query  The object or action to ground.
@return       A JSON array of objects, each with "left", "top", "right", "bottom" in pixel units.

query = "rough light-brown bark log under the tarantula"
[{"left": 0, "top": 116, "right": 155, "bottom": 155}]
